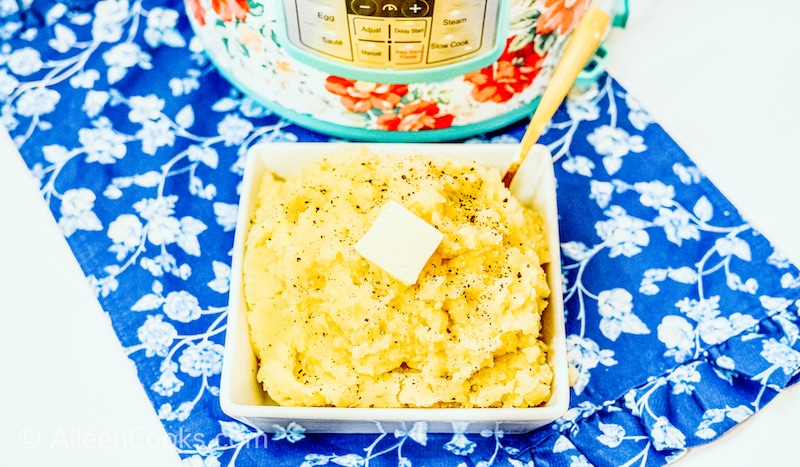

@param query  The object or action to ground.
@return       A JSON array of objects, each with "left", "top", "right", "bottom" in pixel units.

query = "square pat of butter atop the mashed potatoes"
[{"left": 355, "top": 201, "right": 444, "bottom": 285}]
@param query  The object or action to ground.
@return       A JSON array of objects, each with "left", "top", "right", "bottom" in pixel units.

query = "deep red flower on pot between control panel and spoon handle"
[{"left": 464, "top": 37, "right": 543, "bottom": 103}]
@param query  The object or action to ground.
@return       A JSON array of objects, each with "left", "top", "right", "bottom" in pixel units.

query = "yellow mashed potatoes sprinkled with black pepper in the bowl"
[{"left": 244, "top": 149, "right": 553, "bottom": 407}]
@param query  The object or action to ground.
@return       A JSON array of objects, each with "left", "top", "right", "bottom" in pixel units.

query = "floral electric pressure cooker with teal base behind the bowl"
[{"left": 185, "top": 0, "right": 628, "bottom": 142}]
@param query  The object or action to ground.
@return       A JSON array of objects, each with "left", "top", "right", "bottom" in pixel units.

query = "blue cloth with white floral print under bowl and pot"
[{"left": 0, "top": 0, "right": 800, "bottom": 467}]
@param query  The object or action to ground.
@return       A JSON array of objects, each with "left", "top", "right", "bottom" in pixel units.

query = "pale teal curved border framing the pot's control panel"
[{"left": 275, "top": 0, "right": 511, "bottom": 84}]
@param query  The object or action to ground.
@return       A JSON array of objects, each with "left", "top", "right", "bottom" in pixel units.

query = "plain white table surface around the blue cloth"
[{"left": 0, "top": 0, "right": 800, "bottom": 467}]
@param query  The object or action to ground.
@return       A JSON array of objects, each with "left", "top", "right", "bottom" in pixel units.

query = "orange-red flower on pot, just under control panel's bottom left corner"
[{"left": 325, "top": 76, "right": 408, "bottom": 112}]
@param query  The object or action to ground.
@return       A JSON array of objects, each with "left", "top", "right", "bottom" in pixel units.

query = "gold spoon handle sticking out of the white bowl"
[{"left": 503, "top": 7, "right": 611, "bottom": 187}]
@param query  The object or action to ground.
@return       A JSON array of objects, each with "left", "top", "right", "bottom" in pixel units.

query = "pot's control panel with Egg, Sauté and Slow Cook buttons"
[{"left": 282, "top": 0, "right": 507, "bottom": 80}]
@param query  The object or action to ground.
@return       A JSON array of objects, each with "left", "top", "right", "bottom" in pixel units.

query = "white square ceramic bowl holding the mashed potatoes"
[{"left": 220, "top": 143, "right": 569, "bottom": 433}]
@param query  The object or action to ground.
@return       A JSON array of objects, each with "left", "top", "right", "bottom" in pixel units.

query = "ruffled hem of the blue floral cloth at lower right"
[{"left": 513, "top": 298, "right": 800, "bottom": 467}]
